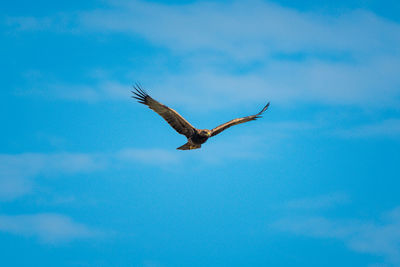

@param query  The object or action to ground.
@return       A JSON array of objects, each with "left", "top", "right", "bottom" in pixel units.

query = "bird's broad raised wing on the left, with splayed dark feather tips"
[{"left": 132, "top": 84, "right": 195, "bottom": 138}]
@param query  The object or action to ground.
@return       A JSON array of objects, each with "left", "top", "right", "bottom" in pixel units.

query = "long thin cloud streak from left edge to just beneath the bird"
[{"left": 0, "top": 139, "right": 265, "bottom": 201}]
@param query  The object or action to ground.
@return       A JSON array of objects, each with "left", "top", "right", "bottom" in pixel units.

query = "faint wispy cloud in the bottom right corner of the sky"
[{"left": 271, "top": 207, "right": 400, "bottom": 266}]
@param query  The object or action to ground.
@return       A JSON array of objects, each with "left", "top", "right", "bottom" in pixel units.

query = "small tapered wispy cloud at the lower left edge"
[{"left": 0, "top": 213, "right": 100, "bottom": 243}]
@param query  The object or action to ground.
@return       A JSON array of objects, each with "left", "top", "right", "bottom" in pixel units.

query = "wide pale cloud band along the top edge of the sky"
[{"left": 79, "top": 1, "right": 400, "bottom": 58}]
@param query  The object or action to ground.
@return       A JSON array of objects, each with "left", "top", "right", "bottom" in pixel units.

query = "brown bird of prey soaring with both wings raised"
[{"left": 132, "top": 84, "right": 269, "bottom": 150}]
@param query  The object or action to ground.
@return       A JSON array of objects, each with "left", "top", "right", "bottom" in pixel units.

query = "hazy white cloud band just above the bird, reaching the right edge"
[{"left": 154, "top": 59, "right": 400, "bottom": 110}]
